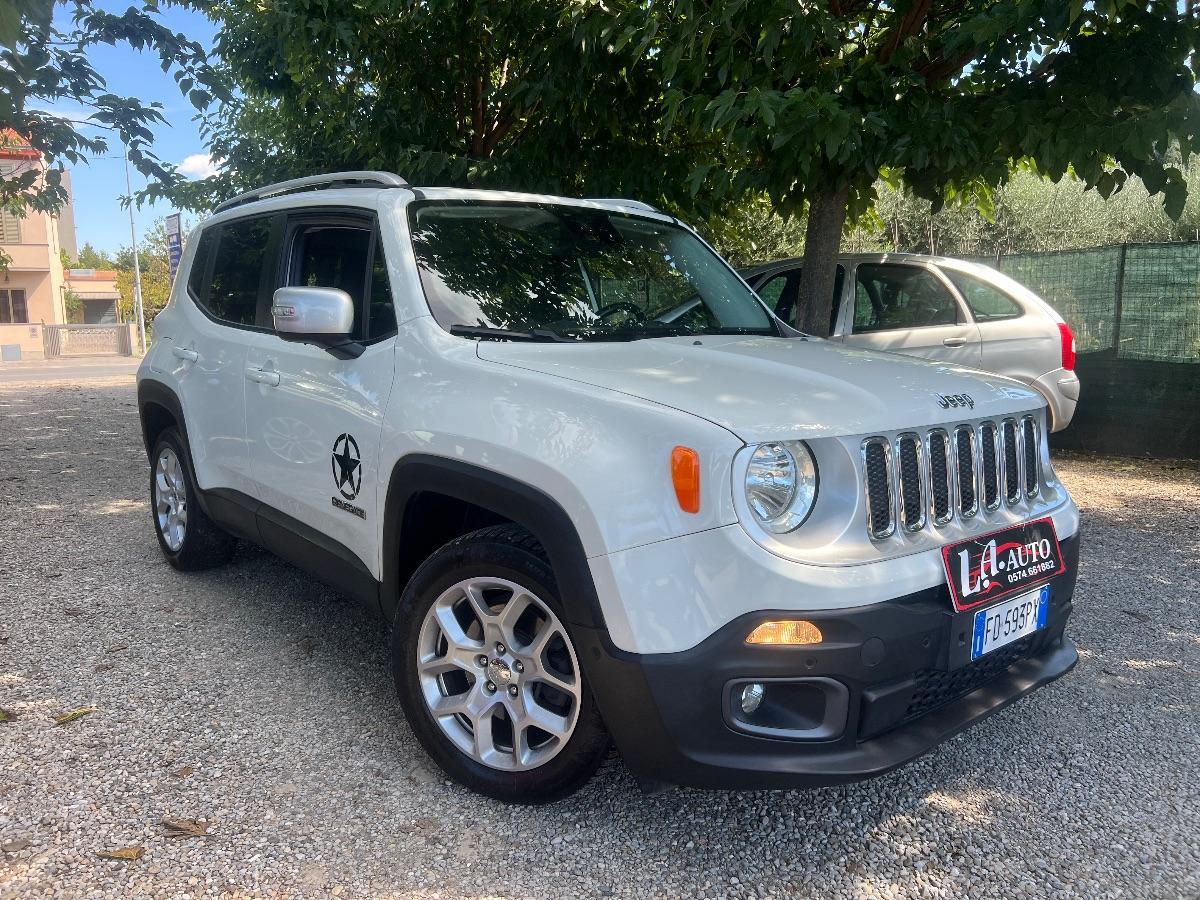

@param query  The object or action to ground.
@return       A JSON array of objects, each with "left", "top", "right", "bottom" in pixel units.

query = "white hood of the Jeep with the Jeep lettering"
[{"left": 478, "top": 336, "right": 1045, "bottom": 443}]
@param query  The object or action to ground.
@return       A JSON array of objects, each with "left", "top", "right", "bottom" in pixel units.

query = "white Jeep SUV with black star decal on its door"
[{"left": 138, "top": 172, "right": 1079, "bottom": 803}]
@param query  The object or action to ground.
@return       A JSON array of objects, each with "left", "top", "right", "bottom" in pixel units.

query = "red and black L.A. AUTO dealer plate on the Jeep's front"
[{"left": 942, "top": 518, "right": 1066, "bottom": 612}]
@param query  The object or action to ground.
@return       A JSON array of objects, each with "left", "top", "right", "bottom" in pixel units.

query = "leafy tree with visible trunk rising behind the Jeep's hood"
[{"left": 577, "top": 0, "right": 1200, "bottom": 334}]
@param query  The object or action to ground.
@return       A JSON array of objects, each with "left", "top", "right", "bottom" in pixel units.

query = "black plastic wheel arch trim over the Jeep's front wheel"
[{"left": 379, "top": 454, "right": 604, "bottom": 630}]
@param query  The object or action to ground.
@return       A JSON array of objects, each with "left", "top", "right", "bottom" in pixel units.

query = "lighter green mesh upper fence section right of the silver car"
[{"left": 979, "top": 242, "right": 1200, "bottom": 362}]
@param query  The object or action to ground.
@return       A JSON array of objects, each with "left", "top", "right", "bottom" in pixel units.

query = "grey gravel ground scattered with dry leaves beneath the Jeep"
[{"left": 0, "top": 377, "right": 1200, "bottom": 898}]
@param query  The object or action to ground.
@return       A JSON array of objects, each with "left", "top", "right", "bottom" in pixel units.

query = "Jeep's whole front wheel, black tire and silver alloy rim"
[{"left": 391, "top": 526, "right": 608, "bottom": 803}]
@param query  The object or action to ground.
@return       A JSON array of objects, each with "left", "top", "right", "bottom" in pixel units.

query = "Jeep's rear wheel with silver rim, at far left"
[{"left": 150, "top": 428, "right": 235, "bottom": 571}]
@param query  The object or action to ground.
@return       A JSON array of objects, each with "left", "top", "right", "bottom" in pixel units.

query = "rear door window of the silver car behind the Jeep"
[{"left": 854, "top": 265, "right": 959, "bottom": 334}]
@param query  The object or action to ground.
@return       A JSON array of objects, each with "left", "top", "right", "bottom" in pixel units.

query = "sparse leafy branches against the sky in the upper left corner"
[{"left": 0, "top": 0, "right": 229, "bottom": 210}]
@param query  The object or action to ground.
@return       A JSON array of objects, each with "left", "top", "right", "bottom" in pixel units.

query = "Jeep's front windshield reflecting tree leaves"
[{"left": 409, "top": 200, "right": 779, "bottom": 341}]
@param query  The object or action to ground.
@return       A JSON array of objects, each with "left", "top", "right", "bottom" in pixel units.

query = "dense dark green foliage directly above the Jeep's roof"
[{"left": 150, "top": 0, "right": 694, "bottom": 209}]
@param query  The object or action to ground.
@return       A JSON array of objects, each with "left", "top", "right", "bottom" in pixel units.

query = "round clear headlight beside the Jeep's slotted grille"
[{"left": 745, "top": 440, "right": 817, "bottom": 534}]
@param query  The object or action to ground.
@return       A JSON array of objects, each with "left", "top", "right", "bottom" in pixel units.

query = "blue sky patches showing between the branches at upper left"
[{"left": 48, "top": 0, "right": 216, "bottom": 251}]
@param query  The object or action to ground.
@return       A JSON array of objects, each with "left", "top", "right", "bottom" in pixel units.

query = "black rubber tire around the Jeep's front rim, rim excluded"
[{"left": 391, "top": 524, "right": 611, "bottom": 804}]
